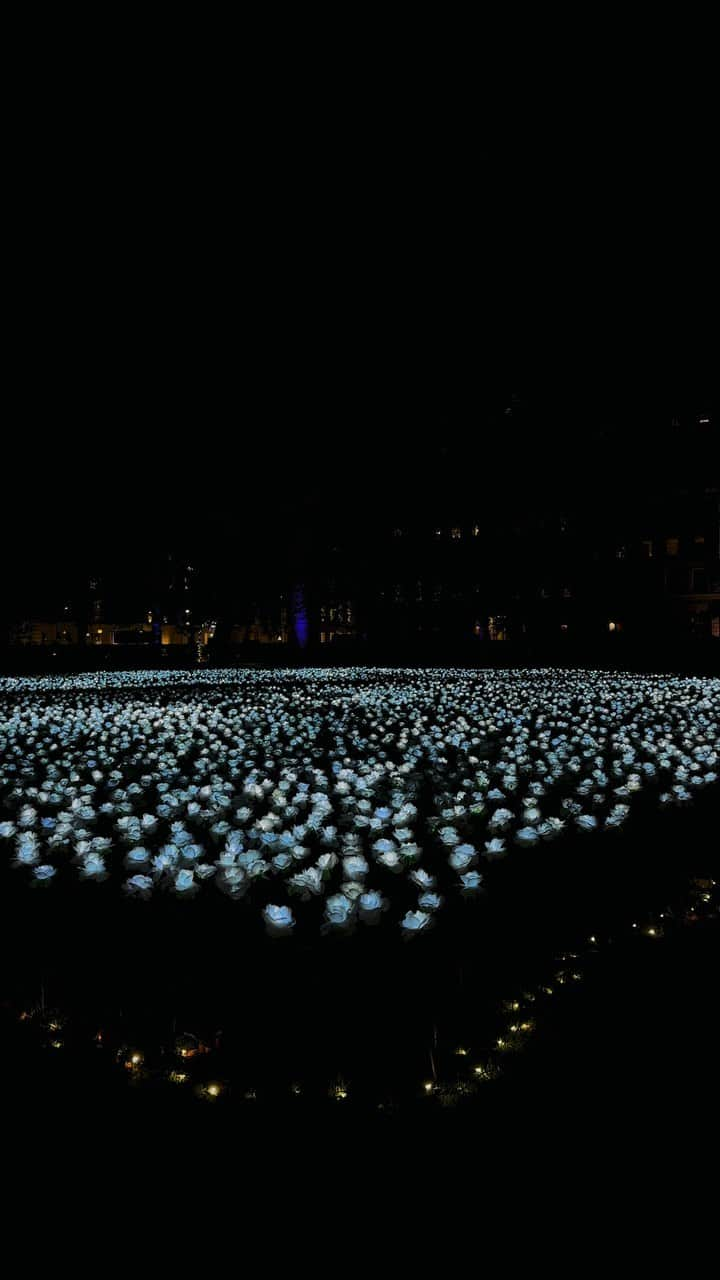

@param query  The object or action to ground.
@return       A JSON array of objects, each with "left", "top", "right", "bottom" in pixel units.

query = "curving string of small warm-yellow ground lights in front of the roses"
[{"left": 8, "top": 877, "right": 720, "bottom": 1111}]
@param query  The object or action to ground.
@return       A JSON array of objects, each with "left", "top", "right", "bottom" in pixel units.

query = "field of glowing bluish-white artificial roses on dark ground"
[{"left": 0, "top": 668, "right": 720, "bottom": 937}]
